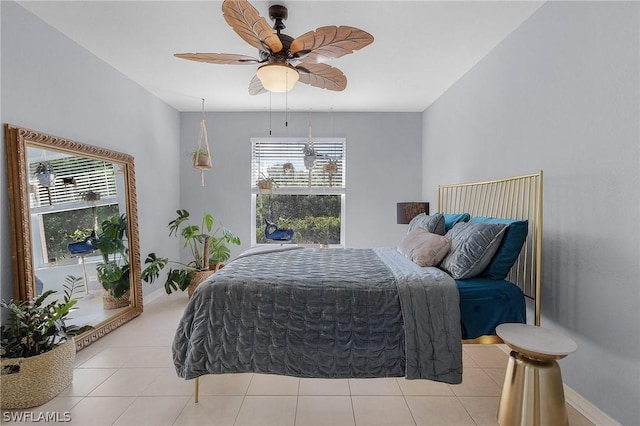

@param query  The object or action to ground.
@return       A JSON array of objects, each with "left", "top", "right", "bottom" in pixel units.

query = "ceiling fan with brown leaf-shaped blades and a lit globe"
[{"left": 174, "top": 0, "right": 373, "bottom": 95}]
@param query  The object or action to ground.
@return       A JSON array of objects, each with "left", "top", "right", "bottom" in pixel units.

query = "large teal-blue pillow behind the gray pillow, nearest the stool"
[{"left": 469, "top": 216, "right": 529, "bottom": 280}]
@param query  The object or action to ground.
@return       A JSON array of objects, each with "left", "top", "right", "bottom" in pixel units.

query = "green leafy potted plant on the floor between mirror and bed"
[{"left": 141, "top": 209, "right": 240, "bottom": 296}]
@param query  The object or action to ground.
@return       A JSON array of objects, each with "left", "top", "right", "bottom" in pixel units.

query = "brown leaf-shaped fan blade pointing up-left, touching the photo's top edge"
[{"left": 222, "top": 0, "right": 282, "bottom": 53}]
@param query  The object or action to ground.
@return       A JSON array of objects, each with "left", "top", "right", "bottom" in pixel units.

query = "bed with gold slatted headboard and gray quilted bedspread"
[{"left": 173, "top": 172, "right": 542, "bottom": 402}]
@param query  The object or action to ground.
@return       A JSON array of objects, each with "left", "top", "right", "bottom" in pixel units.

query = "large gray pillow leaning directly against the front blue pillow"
[{"left": 440, "top": 222, "right": 508, "bottom": 280}]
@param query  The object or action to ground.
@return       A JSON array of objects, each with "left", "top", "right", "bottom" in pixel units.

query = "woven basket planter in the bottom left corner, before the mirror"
[{"left": 0, "top": 339, "right": 76, "bottom": 410}]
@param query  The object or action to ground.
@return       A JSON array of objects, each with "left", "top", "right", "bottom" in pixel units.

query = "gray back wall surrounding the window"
[{"left": 180, "top": 112, "right": 422, "bottom": 260}]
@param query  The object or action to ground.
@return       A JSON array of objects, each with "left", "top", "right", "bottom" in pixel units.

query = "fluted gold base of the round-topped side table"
[{"left": 498, "top": 351, "right": 569, "bottom": 426}]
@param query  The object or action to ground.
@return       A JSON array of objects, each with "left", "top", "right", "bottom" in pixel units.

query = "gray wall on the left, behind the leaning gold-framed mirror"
[{"left": 0, "top": 1, "right": 180, "bottom": 299}]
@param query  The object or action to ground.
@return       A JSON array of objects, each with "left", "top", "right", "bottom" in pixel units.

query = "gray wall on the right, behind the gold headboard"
[{"left": 423, "top": 2, "right": 640, "bottom": 425}]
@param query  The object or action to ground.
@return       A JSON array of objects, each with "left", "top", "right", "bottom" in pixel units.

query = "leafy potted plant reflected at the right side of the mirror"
[{"left": 91, "top": 214, "right": 131, "bottom": 309}]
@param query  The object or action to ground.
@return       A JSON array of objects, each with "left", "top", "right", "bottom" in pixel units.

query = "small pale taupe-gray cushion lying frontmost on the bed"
[{"left": 398, "top": 228, "right": 451, "bottom": 266}]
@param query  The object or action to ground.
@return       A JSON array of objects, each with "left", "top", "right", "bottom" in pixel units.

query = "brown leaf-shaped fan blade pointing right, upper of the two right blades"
[{"left": 289, "top": 26, "right": 373, "bottom": 62}]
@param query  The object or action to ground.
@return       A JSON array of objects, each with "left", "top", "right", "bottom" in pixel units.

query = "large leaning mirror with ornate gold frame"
[{"left": 5, "top": 124, "right": 142, "bottom": 349}]
